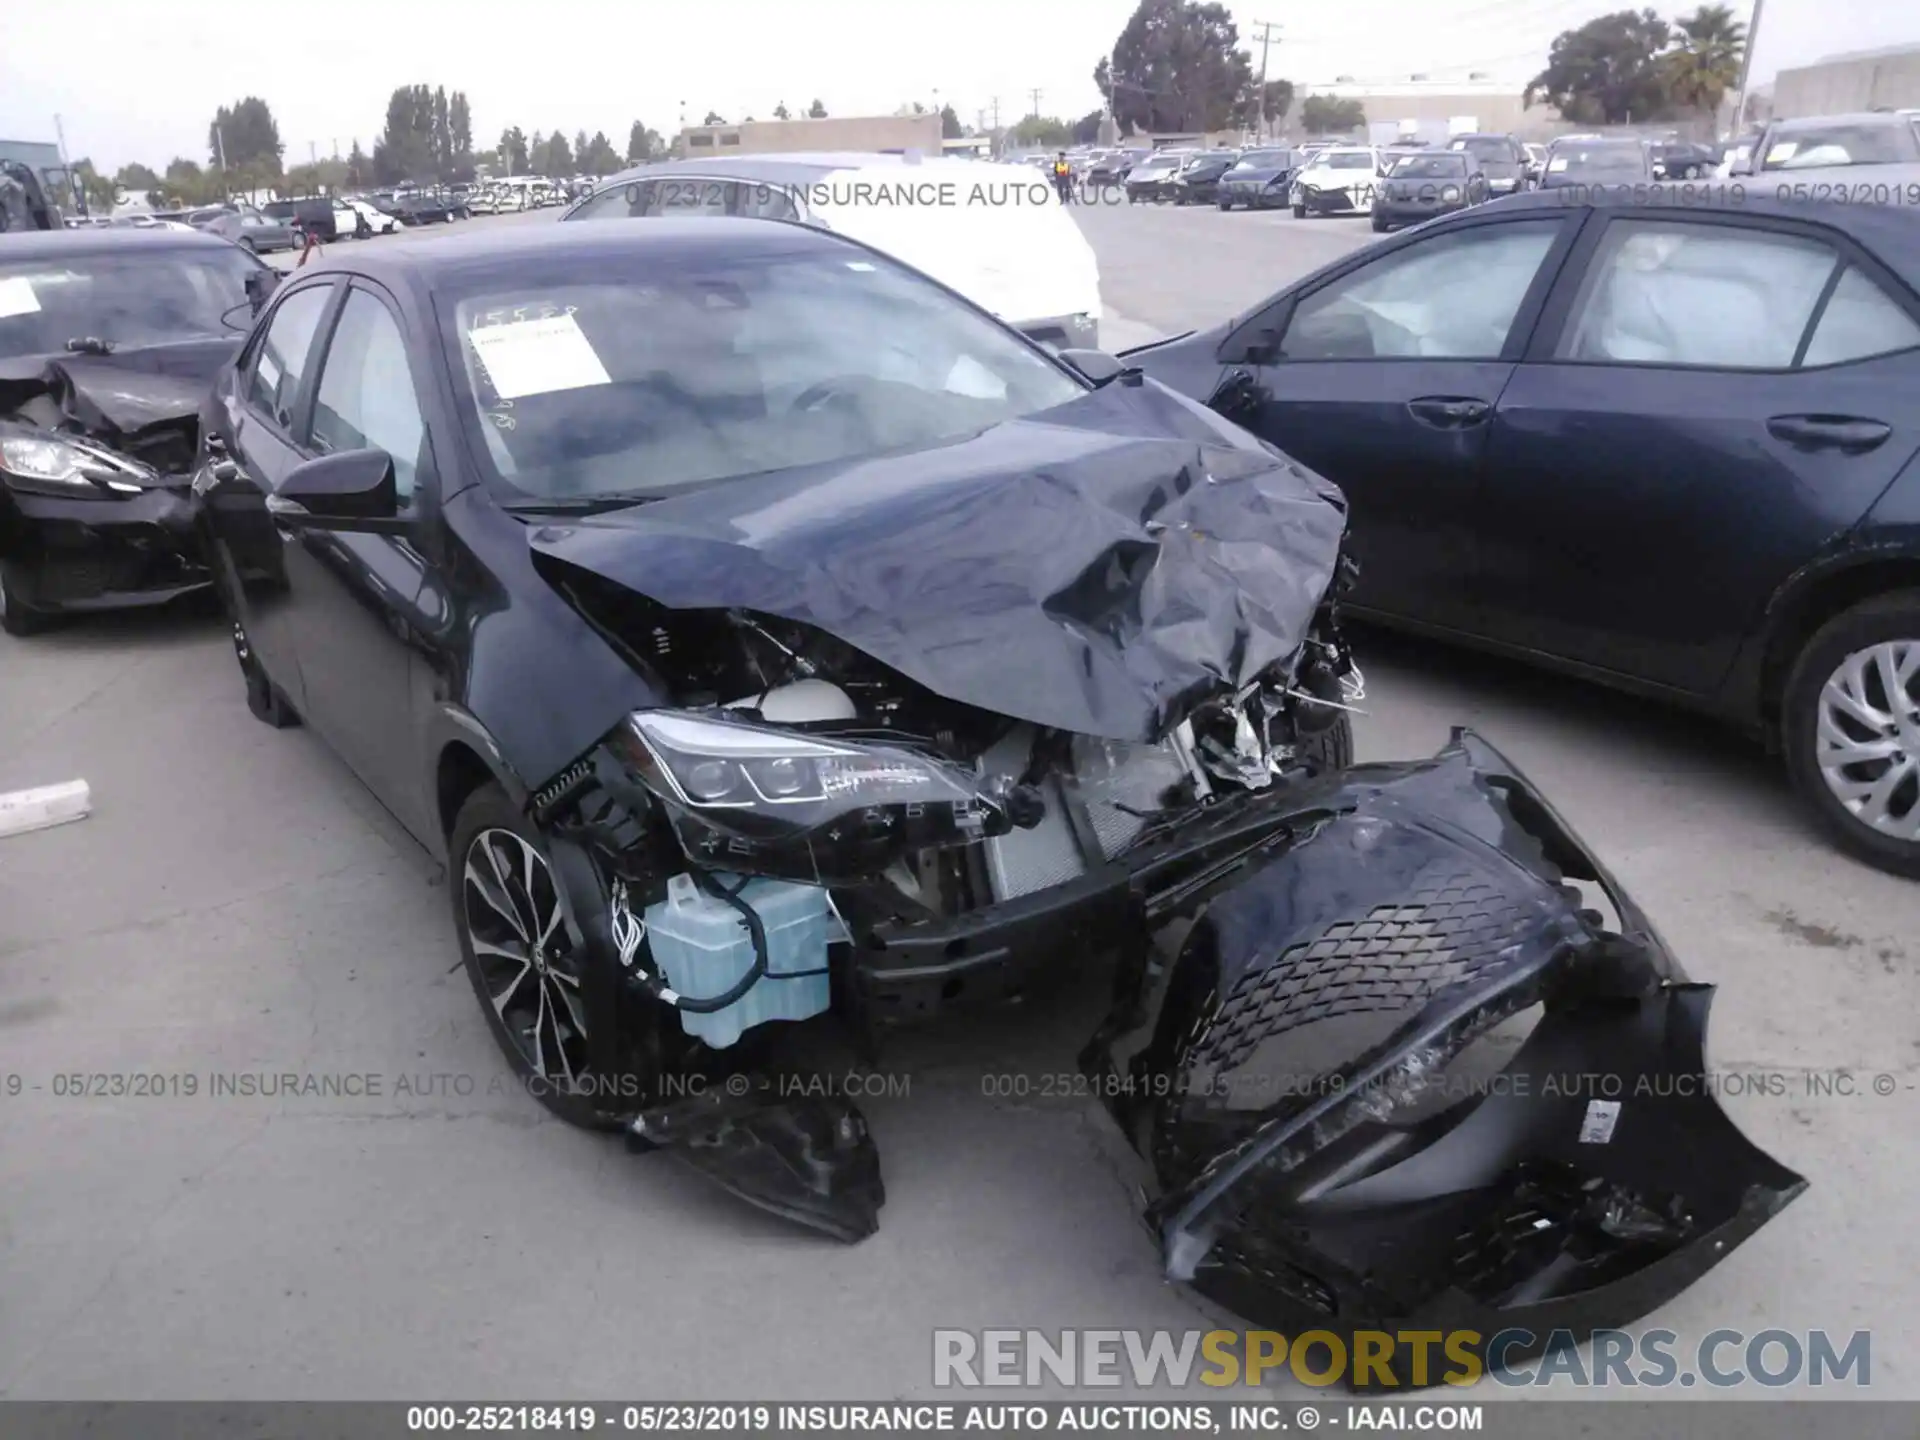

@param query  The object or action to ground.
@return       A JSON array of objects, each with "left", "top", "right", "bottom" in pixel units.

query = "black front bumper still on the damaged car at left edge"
[{"left": 0, "top": 478, "right": 211, "bottom": 614}]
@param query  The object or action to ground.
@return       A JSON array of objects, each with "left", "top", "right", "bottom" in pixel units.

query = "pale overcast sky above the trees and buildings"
[{"left": 0, "top": 0, "right": 1920, "bottom": 171}]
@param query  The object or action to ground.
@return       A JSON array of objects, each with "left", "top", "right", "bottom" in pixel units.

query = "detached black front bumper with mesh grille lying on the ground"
[{"left": 1083, "top": 732, "right": 1805, "bottom": 1384}]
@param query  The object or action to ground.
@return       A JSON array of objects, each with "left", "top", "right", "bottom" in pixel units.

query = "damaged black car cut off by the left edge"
[{"left": 0, "top": 228, "right": 271, "bottom": 634}]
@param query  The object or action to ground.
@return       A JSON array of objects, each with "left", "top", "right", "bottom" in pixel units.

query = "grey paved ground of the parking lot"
[{"left": 0, "top": 205, "right": 1920, "bottom": 1400}]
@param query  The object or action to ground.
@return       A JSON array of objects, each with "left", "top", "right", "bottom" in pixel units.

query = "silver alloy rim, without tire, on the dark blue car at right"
[{"left": 1814, "top": 639, "right": 1920, "bottom": 841}]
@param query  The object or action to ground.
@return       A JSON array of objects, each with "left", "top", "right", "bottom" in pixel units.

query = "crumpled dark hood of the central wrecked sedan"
[{"left": 530, "top": 382, "right": 1346, "bottom": 741}]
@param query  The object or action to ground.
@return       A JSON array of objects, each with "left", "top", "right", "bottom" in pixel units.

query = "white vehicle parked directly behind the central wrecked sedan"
[{"left": 561, "top": 154, "right": 1100, "bottom": 349}]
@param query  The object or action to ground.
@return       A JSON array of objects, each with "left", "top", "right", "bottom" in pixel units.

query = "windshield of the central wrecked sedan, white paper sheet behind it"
[{"left": 436, "top": 248, "right": 1085, "bottom": 501}]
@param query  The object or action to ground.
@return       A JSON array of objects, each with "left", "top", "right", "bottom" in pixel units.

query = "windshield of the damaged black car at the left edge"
[{"left": 0, "top": 246, "right": 259, "bottom": 359}]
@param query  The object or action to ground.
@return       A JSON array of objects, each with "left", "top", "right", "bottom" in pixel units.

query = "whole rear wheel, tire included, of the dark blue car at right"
[{"left": 1780, "top": 589, "right": 1920, "bottom": 879}]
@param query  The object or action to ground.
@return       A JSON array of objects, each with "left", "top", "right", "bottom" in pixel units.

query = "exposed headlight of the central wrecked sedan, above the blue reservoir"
[{"left": 618, "top": 710, "right": 1012, "bottom": 881}]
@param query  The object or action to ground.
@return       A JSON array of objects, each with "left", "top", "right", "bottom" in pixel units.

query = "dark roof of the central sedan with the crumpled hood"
[{"left": 294, "top": 215, "right": 854, "bottom": 288}]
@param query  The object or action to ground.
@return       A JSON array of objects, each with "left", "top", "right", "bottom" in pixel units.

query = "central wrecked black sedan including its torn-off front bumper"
[{"left": 198, "top": 221, "right": 1801, "bottom": 1374}]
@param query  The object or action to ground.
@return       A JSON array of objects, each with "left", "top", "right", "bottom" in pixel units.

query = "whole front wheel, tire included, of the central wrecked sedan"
[{"left": 447, "top": 785, "right": 618, "bottom": 1129}]
